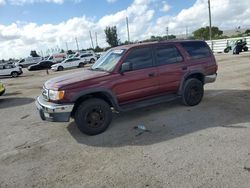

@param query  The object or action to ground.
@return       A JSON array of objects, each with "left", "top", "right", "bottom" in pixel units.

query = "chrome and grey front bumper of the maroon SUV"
[{"left": 36, "top": 95, "right": 74, "bottom": 122}]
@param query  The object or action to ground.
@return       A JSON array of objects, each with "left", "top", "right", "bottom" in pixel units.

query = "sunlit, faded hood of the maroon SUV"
[{"left": 45, "top": 69, "right": 110, "bottom": 90}]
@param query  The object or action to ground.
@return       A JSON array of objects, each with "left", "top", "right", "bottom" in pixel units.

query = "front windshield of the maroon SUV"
[{"left": 91, "top": 49, "right": 125, "bottom": 72}]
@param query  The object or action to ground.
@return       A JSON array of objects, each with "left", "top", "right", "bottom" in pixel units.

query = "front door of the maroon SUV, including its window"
[{"left": 113, "top": 47, "right": 158, "bottom": 104}]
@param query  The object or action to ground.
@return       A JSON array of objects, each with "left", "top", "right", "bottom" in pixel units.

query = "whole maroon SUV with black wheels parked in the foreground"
[{"left": 36, "top": 41, "right": 217, "bottom": 135}]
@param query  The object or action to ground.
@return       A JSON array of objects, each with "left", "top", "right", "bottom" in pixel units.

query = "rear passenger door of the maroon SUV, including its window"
[{"left": 154, "top": 44, "right": 187, "bottom": 93}]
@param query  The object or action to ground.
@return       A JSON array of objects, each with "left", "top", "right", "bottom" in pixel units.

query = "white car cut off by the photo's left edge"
[{"left": 0, "top": 65, "right": 23, "bottom": 78}]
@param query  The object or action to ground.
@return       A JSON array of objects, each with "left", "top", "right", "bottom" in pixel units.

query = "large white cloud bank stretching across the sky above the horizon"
[{"left": 0, "top": 0, "right": 250, "bottom": 59}]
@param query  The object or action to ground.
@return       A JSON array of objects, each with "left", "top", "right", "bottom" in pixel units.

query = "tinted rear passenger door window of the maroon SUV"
[{"left": 156, "top": 46, "right": 183, "bottom": 65}]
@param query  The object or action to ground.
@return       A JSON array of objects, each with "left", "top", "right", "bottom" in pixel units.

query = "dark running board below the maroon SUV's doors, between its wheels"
[{"left": 119, "top": 94, "right": 180, "bottom": 112}]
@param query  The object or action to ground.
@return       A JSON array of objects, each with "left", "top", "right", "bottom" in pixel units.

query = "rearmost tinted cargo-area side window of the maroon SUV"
[{"left": 181, "top": 41, "right": 210, "bottom": 59}]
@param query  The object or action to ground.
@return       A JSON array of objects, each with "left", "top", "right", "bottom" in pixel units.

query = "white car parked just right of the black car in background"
[{"left": 51, "top": 57, "right": 87, "bottom": 71}]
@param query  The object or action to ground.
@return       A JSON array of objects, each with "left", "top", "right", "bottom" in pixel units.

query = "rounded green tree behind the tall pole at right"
[{"left": 193, "top": 26, "right": 223, "bottom": 40}]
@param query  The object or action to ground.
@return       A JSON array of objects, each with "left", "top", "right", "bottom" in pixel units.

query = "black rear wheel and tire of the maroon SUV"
[{"left": 182, "top": 78, "right": 204, "bottom": 106}]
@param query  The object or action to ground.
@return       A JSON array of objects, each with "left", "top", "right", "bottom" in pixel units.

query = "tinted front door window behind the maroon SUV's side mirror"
[{"left": 125, "top": 48, "right": 153, "bottom": 70}]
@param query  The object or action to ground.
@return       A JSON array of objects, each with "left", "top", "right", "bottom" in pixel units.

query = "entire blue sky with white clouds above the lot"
[{"left": 0, "top": 0, "right": 250, "bottom": 59}]
